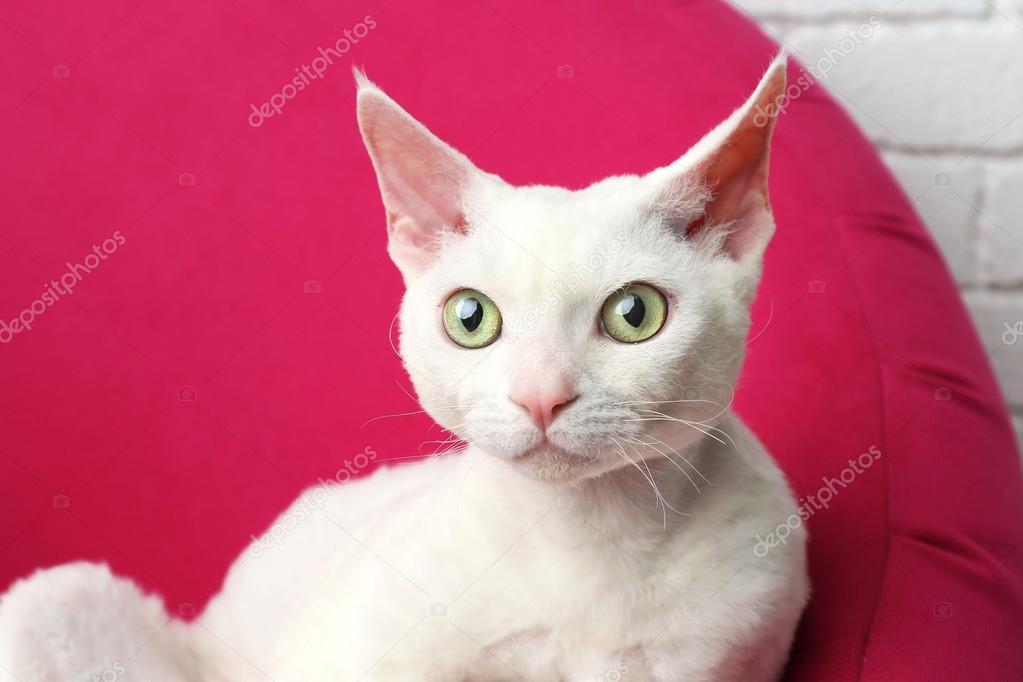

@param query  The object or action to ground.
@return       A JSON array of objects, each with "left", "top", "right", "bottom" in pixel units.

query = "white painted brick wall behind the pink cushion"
[{"left": 732, "top": 0, "right": 1023, "bottom": 458}]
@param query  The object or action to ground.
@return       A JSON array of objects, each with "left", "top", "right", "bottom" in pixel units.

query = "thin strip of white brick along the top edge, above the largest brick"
[{"left": 732, "top": 0, "right": 987, "bottom": 20}]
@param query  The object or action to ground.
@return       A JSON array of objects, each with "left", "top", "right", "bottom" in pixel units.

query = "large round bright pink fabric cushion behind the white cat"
[{"left": 0, "top": 0, "right": 1023, "bottom": 682}]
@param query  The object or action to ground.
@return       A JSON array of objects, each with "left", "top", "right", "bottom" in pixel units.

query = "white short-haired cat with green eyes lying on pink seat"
[{"left": 0, "top": 58, "right": 808, "bottom": 682}]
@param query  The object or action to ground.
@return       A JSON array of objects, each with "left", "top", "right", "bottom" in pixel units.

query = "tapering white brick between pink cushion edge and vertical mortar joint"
[{"left": 883, "top": 152, "right": 981, "bottom": 284}]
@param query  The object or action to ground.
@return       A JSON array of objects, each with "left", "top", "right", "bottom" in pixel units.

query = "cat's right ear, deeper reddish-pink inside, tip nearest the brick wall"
[{"left": 660, "top": 54, "right": 786, "bottom": 264}]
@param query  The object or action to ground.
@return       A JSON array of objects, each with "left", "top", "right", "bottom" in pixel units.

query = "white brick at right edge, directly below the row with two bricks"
[{"left": 967, "top": 292, "right": 1023, "bottom": 410}]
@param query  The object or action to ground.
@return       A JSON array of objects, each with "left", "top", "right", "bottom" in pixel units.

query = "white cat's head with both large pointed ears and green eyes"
[{"left": 356, "top": 57, "right": 786, "bottom": 484}]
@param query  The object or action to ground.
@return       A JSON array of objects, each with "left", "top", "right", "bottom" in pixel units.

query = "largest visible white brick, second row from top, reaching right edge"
[{"left": 787, "top": 24, "right": 1023, "bottom": 152}]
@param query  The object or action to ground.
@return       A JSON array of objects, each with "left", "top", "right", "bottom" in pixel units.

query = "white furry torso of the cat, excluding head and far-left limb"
[{"left": 203, "top": 418, "right": 806, "bottom": 682}]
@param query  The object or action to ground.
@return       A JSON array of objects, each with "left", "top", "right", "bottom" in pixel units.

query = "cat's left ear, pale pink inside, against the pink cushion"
[{"left": 354, "top": 70, "right": 487, "bottom": 281}]
